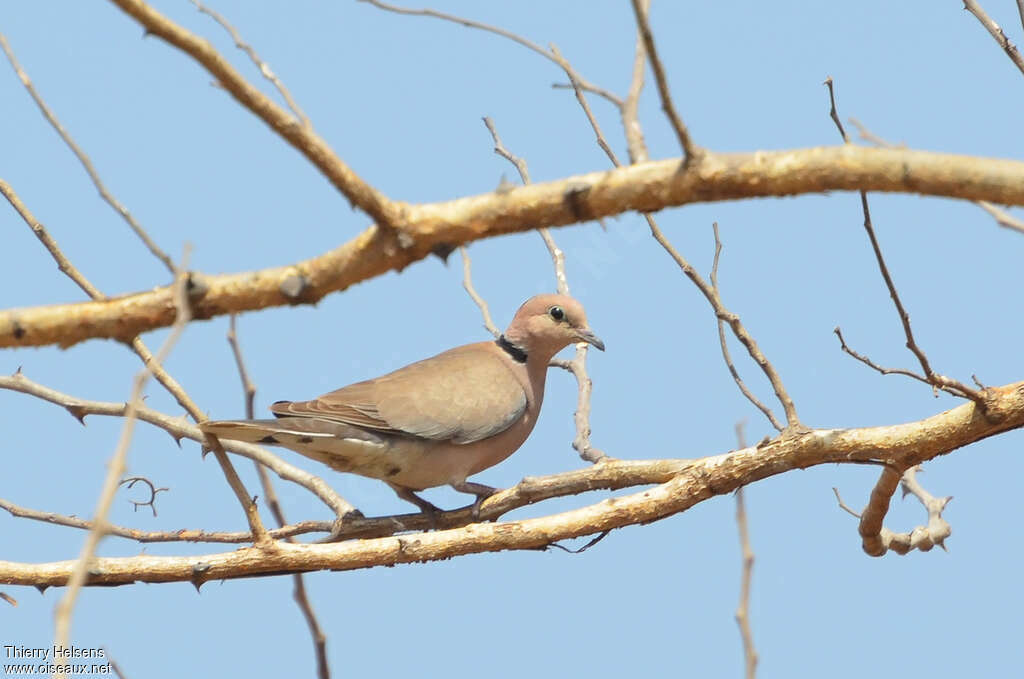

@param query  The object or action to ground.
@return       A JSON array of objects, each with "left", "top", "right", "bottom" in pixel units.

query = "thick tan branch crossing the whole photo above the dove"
[{"left": 6, "top": 145, "right": 1024, "bottom": 348}]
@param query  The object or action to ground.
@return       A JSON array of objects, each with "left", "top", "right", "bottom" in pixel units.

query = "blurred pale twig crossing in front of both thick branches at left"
[{"left": 53, "top": 247, "right": 191, "bottom": 676}]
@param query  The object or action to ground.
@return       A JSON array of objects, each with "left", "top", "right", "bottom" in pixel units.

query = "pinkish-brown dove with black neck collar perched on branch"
[{"left": 199, "top": 295, "right": 604, "bottom": 513}]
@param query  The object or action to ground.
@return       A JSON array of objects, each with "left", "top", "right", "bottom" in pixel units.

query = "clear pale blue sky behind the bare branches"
[{"left": 0, "top": 0, "right": 1024, "bottom": 678}]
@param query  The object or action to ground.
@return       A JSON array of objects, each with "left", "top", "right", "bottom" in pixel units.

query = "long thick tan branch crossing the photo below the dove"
[{"left": 8, "top": 382, "right": 1024, "bottom": 587}]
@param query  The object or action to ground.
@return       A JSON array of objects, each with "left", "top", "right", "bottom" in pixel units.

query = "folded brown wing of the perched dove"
[{"left": 270, "top": 342, "right": 526, "bottom": 443}]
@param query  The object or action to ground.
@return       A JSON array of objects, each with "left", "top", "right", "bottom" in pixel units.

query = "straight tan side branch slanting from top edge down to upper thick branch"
[{"left": 111, "top": 0, "right": 402, "bottom": 228}]
